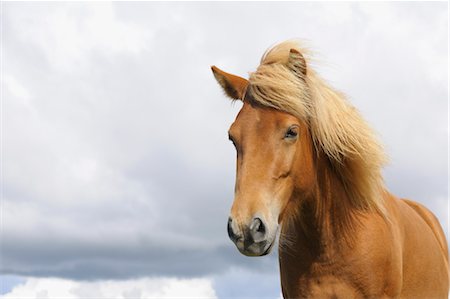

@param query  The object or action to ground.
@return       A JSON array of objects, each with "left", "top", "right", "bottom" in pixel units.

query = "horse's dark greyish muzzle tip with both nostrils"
[{"left": 227, "top": 217, "right": 274, "bottom": 256}]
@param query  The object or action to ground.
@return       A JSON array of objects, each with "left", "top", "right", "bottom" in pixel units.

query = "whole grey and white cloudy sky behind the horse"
[{"left": 0, "top": 2, "right": 448, "bottom": 298}]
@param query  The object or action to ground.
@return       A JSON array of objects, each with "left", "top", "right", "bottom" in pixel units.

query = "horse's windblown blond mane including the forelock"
[{"left": 248, "top": 40, "right": 387, "bottom": 215}]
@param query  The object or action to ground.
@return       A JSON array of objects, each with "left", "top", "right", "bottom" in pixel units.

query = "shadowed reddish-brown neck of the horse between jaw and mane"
[{"left": 280, "top": 155, "right": 358, "bottom": 256}]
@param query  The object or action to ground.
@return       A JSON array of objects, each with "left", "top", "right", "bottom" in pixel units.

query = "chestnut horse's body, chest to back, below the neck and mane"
[{"left": 279, "top": 193, "right": 448, "bottom": 298}]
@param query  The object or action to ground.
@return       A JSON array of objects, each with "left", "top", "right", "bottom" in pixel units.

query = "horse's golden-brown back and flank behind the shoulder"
[{"left": 389, "top": 195, "right": 449, "bottom": 298}]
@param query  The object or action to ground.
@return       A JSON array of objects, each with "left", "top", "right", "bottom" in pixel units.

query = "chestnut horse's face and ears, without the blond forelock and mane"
[{"left": 212, "top": 50, "right": 314, "bottom": 256}]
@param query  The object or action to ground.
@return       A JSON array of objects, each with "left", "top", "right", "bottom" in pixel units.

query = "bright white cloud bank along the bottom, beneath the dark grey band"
[{"left": 2, "top": 277, "right": 217, "bottom": 299}]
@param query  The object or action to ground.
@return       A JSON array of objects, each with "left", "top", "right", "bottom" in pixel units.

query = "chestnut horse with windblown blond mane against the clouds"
[{"left": 211, "top": 40, "right": 449, "bottom": 298}]
